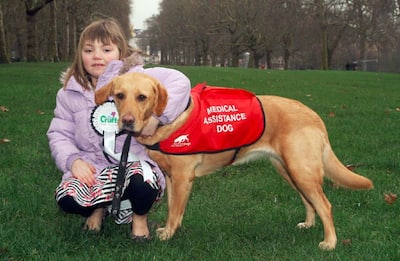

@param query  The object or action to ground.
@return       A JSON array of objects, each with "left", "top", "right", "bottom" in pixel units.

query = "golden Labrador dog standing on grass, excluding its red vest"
[{"left": 95, "top": 73, "right": 373, "bottom": 250}]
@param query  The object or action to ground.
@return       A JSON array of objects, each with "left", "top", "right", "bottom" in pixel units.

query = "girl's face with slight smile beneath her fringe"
[{"left": 82, "top": 40, "right": 120, "bottom": 86}]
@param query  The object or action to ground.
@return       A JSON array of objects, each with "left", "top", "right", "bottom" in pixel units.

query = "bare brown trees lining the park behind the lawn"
[{"left": 0, "top": 0, "right": 400, "bottom": 72}]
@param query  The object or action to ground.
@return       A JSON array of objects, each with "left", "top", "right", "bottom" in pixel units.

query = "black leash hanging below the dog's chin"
[{"left": 111, "top": 133, "right": 132, "bottom": 219}]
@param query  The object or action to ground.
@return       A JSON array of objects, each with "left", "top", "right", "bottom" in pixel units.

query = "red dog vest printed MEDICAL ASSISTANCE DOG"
[{"left": 154, "top": 83, "right": 265, "bottom": 154}]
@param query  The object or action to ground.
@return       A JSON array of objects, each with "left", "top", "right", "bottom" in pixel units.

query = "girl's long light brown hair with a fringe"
[{"left": 63, "top": 18, "right": 135, "bottom": 90}]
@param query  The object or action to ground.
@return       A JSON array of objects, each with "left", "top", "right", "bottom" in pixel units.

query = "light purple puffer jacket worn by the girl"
[{"left": 47, "top": 61, "right": 191, "bottom": 188}]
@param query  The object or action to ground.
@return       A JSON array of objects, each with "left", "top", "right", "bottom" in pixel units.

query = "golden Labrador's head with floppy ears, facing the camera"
[{"left": 95, "top": 72, "right": 168, "bottom": 135}]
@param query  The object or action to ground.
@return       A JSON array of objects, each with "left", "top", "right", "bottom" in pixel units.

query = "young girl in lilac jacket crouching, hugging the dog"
[{"left": 47, "top": 19, "right": 191, "bottom": 241}]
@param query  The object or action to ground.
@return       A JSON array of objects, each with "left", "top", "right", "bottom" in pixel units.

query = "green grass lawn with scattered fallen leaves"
[{"left": 0, "top": 63, "right": 400, "bottom": 260}]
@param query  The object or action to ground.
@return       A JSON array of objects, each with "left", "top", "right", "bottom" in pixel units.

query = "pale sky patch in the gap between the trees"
[{"left": 130, "top": 0, "right": 161, "bottom": 29}]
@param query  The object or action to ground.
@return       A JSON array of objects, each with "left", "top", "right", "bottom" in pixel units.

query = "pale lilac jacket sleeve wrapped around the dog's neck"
[{"left": 144, "top": 67, "right": 191, "bottom": 124}]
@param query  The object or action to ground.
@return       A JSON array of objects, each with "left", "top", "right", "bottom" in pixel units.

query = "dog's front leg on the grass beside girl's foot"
[{"left": 157, "top": 170, "right": 193, "bottom": 240}]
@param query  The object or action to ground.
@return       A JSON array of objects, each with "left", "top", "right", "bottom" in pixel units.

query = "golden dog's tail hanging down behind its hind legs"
[{"left": 324, "top": 146, "right": 374, "bottom": 189}]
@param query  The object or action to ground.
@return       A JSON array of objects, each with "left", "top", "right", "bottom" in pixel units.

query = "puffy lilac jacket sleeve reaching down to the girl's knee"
[{"left": 47, "top": 89, "right": 80, "bottom": 173}]
